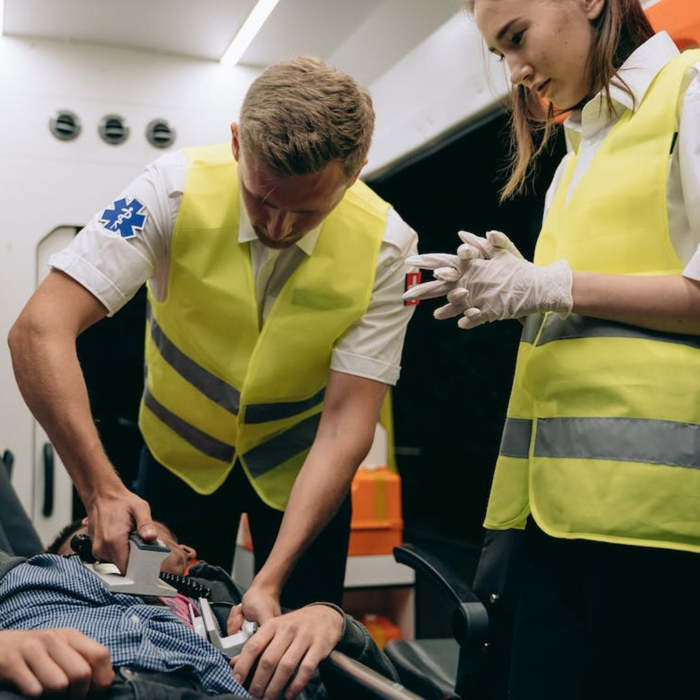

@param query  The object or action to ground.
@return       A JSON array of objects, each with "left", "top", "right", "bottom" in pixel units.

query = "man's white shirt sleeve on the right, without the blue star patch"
[{"left": 331, "top": 209, "right": 418, "bottom": 385}]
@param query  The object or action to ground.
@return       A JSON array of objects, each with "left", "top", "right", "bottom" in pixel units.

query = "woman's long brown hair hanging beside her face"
[{"left": 467, "top": 0, "right": 654, "bottom": 201}]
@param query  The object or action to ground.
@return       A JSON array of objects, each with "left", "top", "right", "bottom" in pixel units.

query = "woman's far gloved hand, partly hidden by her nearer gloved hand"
[{"left": 403, "top": 231, "right": 508, "bottom": 304}]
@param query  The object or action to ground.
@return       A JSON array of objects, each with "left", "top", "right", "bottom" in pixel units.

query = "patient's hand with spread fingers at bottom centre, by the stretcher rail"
[{"left": 231, "top": 605, "right": 344, "bottom": 700}]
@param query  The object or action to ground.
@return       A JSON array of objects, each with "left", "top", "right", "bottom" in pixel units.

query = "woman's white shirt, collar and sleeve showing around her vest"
[{"left": 545, "top": 32, "right": 700, "bottom": 280}]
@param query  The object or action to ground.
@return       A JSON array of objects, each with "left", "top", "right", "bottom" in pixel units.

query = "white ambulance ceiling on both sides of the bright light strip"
[{"left": 0, "top": 0, "right": 462, "bottom": 84}]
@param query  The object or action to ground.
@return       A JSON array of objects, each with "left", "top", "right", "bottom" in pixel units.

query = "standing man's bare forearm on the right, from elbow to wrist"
[{"left": 250, "top": 426, "right": 373, "bottom": 589}]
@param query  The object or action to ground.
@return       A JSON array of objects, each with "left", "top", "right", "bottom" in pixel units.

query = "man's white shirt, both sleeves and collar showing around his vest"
[{"left": 49, "top": 151, "right": 417, "bottom": 385}]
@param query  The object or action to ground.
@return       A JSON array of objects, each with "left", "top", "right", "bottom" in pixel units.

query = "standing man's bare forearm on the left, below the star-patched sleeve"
[{"left": 9, "top": 319, "right": 121, "bottom": 505}]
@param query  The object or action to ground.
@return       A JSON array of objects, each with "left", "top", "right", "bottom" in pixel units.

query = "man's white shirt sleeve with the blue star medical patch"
[{"left": 49, "top": 153, "right": 184, "bottom": 316}]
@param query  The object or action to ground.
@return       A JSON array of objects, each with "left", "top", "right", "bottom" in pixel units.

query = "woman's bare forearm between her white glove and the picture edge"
[{"left": 573, "top": 272, "right": 700, "bottom": 335}]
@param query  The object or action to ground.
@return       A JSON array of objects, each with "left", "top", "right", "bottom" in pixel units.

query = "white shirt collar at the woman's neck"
[{"left": 564, "top": 32, "right": 679, "bottom": 143}]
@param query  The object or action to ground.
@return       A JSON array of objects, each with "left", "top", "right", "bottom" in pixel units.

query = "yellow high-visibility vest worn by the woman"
[{"left": 485, "top": 51, "right": 700, "bottom": 551}]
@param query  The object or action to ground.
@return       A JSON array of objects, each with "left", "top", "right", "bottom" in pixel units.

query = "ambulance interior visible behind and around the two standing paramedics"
[{"left": 0, "top": 0, "right": 700, "bottom": 697}]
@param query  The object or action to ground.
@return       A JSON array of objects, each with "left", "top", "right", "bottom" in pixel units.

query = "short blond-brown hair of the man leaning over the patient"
[{"left": 239, "top": 56, "right": 374, "bottom": 179}]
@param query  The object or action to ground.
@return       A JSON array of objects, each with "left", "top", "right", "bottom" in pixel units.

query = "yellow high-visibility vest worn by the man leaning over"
[{"left": 139, "top": 145, "right": 389, "bottom": 510}]
